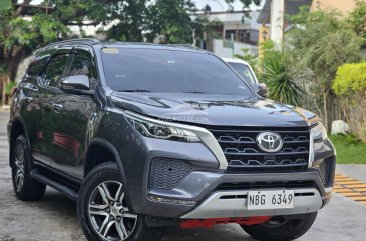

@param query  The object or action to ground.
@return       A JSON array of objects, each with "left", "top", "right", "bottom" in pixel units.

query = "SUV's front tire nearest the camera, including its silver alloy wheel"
[{"left": 77, "top": 162, "right": 162, "bottom": 241}]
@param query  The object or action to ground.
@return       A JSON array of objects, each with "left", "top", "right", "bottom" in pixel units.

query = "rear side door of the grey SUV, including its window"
[{"left": 32, "top": 48, "right": 71, "bottom": 165}]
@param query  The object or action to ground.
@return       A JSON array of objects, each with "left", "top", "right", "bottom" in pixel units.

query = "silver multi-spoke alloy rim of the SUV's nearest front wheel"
[{"left": 88, "top": 181, "right": 137, "bottom": 241}]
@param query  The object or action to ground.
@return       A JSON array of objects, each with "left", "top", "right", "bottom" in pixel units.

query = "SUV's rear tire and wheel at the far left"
[{"left": 11, "top": 135, "right": 46, "bottom": 201}]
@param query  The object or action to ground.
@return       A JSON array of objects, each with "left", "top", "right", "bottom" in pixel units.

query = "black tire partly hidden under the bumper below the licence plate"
[{"left": 241, "top": 212, "right": 318, "bottom": 241}]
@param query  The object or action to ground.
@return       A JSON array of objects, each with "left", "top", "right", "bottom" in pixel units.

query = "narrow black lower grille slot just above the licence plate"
[{"left": 217, "top": 181, "right": 316, "bottom": 191}]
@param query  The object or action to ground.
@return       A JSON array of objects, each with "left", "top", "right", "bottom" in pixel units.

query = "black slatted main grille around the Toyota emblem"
[{"left": 210, "top": 127, "right": 310, "bottom": 171}]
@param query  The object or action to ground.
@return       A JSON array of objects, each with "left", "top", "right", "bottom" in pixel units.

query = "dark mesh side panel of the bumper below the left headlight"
[{"left": 149, "top": 159, "right": 193, "bottom": 190}]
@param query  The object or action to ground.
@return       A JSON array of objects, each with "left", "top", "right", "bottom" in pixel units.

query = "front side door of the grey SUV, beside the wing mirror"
[{"left": 51, "top": 47, "right": 97, "bottom": 179}]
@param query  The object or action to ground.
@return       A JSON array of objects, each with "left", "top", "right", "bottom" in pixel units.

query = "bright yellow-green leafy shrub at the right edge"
[{"left": 333, "top": 62, "right": 366, "bottom": 96}]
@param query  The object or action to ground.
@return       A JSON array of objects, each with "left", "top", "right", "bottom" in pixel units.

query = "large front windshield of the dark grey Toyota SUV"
[{"left": 101, "top": 48, "right": 252, "bottom": 96}]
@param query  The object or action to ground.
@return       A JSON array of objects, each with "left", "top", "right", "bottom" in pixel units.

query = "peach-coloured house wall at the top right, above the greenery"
[{"left": 311, "top": 0, "right": 356, "bottom": 12}]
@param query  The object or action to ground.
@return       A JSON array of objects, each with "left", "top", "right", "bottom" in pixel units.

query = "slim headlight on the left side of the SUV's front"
[{"left": 124, "top": 112, "right": 200, "bottom": 142}]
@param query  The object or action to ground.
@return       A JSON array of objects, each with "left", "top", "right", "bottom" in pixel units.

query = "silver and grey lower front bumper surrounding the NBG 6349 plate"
[{"left": 145, "top": 169, "right": 333, "bottom": 219}]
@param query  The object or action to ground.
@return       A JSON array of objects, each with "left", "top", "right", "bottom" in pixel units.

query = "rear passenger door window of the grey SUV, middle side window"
[{"left": 42, "top": 54, "right": 69, "bottom": 87}]
